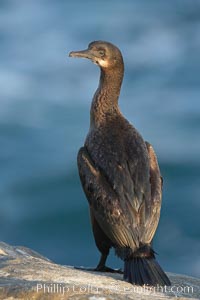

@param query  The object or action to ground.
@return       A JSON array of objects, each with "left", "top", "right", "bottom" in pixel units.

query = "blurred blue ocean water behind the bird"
[{"left": 0, "top": 0, "right": 200, "bottom": 276}]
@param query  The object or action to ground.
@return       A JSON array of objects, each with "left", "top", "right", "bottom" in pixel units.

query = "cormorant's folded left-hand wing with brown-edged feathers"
[{"left": 78, "top": 147, "right": 139, "bottom": 249}]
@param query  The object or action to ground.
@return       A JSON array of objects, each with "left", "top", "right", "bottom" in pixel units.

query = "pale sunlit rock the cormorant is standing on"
[{"left": 0, "top": 242, "right": 200, "bottom": 300}]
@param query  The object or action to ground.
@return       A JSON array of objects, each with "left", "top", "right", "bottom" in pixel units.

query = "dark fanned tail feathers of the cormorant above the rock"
[{"left": 124, "top": 257, "right": 171, "bottom": 286}]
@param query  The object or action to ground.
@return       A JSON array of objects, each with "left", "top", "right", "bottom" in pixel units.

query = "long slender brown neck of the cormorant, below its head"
[{"left": 90, "top": 65, "right": 124, "bottom": 128}]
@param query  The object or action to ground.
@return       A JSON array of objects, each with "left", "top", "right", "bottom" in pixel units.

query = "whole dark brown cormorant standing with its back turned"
[{"left": 69, "top": 41, "right": 170, "bottom": 286}]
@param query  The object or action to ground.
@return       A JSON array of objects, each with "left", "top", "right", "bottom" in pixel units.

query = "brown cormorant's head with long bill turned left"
[{"left": 69, "top": 41, "right": 123, "bottom": 69}]
